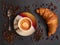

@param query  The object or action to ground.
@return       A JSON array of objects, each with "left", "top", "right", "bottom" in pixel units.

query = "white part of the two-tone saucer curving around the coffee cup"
[{"left": 14, "top": 15, "right": 35, "bottom": 36}]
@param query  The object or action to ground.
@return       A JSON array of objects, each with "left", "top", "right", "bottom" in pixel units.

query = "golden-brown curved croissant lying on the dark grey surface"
[{"left": 36, "top": 8, "right": 58, "bottom": 36}]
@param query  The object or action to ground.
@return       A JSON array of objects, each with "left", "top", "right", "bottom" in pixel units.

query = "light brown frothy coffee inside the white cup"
[{"left": 20, "top": 18, "right": 31, "bottom": 30}]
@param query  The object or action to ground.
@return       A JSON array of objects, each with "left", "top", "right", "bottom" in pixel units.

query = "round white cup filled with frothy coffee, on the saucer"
[{"left": 18, "top": 17, "right": 32, "bottom": 32}]
